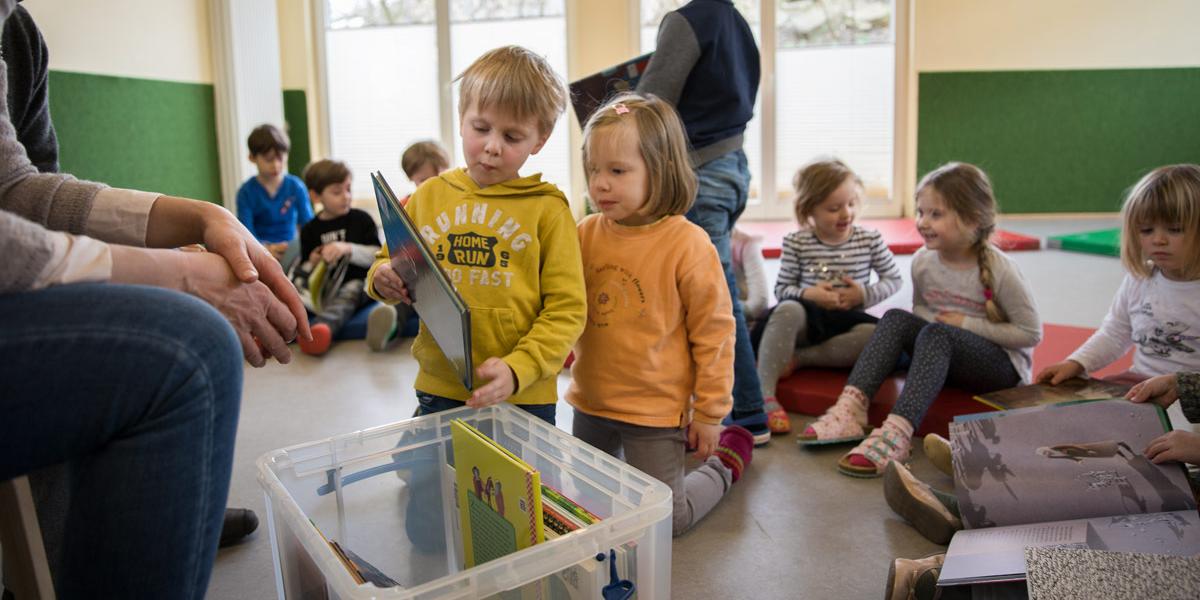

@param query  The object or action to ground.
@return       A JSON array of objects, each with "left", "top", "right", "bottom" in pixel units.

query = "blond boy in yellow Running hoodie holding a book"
[{"left": 367, "top": 46, "right": 587, "bottom": 424}]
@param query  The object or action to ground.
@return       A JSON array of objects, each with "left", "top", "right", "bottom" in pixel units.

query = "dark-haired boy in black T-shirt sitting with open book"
[{"left": 299, "top": 160, "right": 379, "bottom": 355}]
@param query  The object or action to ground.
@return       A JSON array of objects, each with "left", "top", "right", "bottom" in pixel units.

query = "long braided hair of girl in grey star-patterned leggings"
[{"left": 917, "top": 162, "right": 1008, "bottom": 323}]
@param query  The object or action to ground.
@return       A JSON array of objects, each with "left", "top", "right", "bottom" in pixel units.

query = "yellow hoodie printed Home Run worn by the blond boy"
[{"left": 367, "top": 169, "right": 587, "bottom": 404}]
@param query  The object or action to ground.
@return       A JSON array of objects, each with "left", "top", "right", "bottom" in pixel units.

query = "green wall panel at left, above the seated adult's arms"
[{"left": 50, "top": 71, "right": 221, "bottom": 202}]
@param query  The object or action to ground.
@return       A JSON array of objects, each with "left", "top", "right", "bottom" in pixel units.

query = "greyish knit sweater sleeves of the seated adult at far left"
[{"left": 0, "top": 62, "right": 104, "bottom": 292}]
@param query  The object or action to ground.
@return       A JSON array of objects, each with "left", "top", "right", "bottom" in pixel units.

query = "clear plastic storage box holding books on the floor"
[{"left": 258, "top": 403, "right": 671, "bottom": 600}]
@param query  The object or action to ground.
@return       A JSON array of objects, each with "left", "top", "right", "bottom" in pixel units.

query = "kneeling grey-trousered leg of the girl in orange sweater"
[{"left": 619, "top": 424, "right": 729, "bottom": 535}]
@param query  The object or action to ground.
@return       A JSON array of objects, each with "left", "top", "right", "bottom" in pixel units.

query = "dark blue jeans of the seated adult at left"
[{"left": 0, "top": 283, "right": 242, "bottom": 599}]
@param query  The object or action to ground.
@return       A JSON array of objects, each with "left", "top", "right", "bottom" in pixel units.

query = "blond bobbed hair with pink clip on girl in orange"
[{"left": 583, "top": 94, "right": 697, "bottom": 218}]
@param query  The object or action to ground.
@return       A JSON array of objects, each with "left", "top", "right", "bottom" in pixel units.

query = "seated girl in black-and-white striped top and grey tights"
[{"left": 758, "top": 161, "right": 902, "bottom": 433}]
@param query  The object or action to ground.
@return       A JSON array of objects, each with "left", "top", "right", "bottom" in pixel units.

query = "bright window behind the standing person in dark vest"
[{"left": 641, "top": 0, "right": 899, "bottom": 218}]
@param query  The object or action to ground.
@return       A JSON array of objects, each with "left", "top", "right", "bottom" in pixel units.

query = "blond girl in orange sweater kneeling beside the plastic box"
[{"left": 566, "top": 94, "right": 754, "bottom": 535}]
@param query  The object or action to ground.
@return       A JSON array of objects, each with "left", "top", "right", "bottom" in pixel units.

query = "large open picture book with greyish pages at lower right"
[{"left": 938, "top": 400, "right": 1200, "bottom": 586}]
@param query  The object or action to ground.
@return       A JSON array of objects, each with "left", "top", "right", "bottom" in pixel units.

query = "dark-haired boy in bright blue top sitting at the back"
[{"left": 238, "top": 125, "right": 312, "bottom": 259}]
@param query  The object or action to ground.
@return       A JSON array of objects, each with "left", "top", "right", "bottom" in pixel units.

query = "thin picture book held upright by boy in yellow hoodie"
[{"left": 371, "top": 172, "right": 475, "bottom": 390}]
